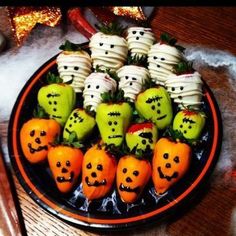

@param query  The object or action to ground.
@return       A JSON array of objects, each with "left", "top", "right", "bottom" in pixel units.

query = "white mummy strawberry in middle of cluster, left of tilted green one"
[{"left": 117, "top": 58, "right": 150, "bottom": 102}]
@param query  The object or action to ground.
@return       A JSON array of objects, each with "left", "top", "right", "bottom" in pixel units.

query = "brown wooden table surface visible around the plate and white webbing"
[{"left": 0, "top": 7, "right": 236, "bottom": 236}]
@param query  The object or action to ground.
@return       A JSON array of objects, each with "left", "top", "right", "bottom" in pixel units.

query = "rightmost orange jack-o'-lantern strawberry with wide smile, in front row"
[{"left": 152, "top": 137, "right": 191, "bottom": 195}]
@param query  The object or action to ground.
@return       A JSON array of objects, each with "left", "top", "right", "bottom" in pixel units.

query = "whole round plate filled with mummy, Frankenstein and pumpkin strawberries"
[{"left": 8, "top": 23, "right": 222, "bottom": 229}]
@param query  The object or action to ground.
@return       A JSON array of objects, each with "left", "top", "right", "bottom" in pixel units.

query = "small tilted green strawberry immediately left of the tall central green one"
[{"left": 63, "top": 108, "right": 96, "bottom": 141}]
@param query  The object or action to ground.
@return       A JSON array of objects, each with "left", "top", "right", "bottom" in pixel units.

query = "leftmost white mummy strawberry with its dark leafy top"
[{"left": 57, "top": 41, "right": 92, "bottom": 93}]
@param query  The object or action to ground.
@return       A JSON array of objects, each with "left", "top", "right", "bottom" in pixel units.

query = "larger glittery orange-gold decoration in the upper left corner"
[{"left": 7, "top": 7, "right": 62, "bottom": 46}]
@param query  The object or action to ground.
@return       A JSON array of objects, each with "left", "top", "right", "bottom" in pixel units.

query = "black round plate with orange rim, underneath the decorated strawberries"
[{"left": 8, "top": 45, "right": 222, "bottom": 229}]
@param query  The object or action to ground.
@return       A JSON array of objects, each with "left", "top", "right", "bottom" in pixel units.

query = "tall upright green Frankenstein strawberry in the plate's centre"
[{"left": 96, "top": 103, "right": 132, "bottom": 146}]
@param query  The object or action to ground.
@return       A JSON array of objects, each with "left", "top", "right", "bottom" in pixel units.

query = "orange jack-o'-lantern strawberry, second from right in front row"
[{"left": 116, "top": 155, "right": 151, "bottom": 203}]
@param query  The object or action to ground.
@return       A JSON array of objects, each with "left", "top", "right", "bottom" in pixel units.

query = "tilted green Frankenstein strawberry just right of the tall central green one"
[{"left": 135, "top": 86, "right": 173, "bottom": 129}]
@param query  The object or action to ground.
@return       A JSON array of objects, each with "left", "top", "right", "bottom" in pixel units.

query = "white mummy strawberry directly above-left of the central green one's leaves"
[{"left": 83, "top": 72, "right": 117, "bottom": 111}]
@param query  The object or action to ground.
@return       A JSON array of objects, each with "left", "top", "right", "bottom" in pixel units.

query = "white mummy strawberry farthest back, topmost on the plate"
[{"left": 126, "top": 27, "right": 156, "bottom": 56}]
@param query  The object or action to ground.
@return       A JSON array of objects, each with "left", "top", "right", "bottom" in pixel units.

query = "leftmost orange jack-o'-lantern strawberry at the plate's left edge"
[{"left": 20, "top": 118, "right": 61, "bottom": 163}]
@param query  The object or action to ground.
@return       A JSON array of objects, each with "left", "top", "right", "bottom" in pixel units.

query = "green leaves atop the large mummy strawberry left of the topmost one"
[{"left": 95, "top": 21, "right": 126, "bottom": 36}]
